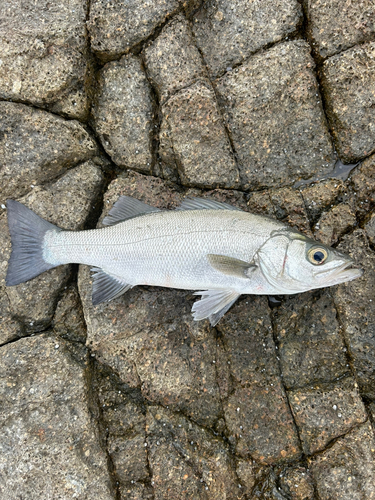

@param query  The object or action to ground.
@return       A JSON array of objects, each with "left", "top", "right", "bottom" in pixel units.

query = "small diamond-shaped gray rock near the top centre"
[{"left": 144, "top": 15, "right": 206, "bottom": 102}]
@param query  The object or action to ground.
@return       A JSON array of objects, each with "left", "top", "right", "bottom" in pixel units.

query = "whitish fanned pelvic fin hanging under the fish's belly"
[{"left": 191, "top": 290, "right": 240, "bottom": 326}]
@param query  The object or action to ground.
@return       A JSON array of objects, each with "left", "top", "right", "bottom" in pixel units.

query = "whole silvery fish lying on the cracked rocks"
[{"left": 6, "top": 196, "right": 363, "bottom": 326}]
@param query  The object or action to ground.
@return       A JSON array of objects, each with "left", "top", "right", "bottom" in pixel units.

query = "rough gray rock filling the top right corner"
[{"left": 306, "top": 0, "right": 375, "bottom": 58}]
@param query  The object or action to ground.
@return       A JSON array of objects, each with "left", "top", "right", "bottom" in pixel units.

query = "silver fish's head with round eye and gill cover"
[{"left": 257, "top": 228, "right": 363, "bottom": 294}]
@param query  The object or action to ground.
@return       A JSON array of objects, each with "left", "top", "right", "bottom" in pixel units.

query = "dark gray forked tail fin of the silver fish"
[{"left": 6, "top": 200, "right": 61, "bottom": 286}]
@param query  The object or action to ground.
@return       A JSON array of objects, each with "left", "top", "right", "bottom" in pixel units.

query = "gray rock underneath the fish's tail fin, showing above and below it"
[{"left": 0, "top": 162, "right": 103, "bottom": 331}]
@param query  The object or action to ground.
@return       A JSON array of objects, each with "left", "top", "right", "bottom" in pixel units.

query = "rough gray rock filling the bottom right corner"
[{"left": 310, "top": 423, "right": 375, "bottom": 500}]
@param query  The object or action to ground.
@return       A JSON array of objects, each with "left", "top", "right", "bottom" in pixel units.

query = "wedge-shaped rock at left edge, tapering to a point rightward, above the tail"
[{"left": 0, "top": 102, "right": 98, "bottom": 204}]
